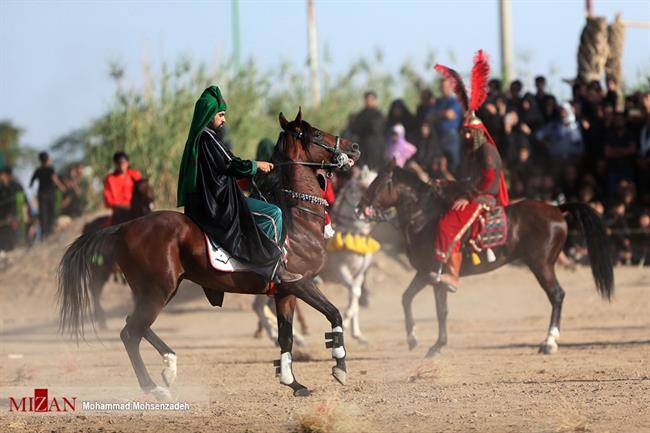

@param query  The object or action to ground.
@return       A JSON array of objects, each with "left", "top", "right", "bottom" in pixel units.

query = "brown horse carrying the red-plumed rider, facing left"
[{"left": 357, "top": 161, "right": 614, "bottom": 357}]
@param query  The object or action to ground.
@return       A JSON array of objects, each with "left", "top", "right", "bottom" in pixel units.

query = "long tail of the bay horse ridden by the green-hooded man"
[{"left": 57, "top": 226, "right": 119, "bottom": 341}]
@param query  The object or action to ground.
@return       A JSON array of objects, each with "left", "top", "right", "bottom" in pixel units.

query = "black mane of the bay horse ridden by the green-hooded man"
[{"left": 254, "top": 120, "right": 312, "bottom": 239}]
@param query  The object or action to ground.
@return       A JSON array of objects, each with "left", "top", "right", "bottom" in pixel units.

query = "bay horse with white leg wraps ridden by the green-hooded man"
[{"left": 58, "top": 112, "right": 359, "bottom": 398}]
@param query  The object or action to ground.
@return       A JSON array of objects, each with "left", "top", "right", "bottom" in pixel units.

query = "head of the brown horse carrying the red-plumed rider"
[{"left": 356, "top": 159, "right": 399, "bottom": 221}]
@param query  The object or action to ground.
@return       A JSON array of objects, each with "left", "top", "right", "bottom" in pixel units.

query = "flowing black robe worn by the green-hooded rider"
[{"left": 185, "top": 129, "right": 282, "bottom": 279}]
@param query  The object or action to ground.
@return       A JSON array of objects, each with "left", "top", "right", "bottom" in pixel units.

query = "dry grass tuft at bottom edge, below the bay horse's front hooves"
[{"left": 295, "top": 397, "right": 374, "bottom": 433}]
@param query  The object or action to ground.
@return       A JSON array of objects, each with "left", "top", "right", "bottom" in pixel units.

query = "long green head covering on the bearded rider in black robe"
[{"left": 177, "top": 86, "right": 228, "bottom": 206}]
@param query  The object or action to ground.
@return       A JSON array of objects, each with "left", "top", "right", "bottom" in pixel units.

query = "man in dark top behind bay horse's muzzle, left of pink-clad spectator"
[{"left": 349, "top": 91, "right": 386, "bottom": 170}]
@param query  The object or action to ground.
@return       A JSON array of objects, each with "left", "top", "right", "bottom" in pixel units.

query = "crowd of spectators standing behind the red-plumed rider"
[{"left": 344, "top": 76, "right": 650, "bottom": 265}]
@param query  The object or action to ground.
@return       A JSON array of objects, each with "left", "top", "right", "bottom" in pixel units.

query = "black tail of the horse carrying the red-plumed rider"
[{"left": 559, "top": 203, "right": 614, "bottom": 301}]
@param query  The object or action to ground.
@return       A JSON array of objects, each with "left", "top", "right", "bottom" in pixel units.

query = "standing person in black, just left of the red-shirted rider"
[{"left": 29, "top": 152, "right": 65, "bottom": 239}]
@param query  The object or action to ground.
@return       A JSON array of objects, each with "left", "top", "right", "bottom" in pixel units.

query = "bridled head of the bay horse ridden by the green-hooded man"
[{"left": 279, "top": 110, "right": 361, "bottom": 171}]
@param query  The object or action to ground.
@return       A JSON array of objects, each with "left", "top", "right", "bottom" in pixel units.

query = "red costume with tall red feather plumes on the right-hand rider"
[{"left": 435, "top": 50, "right": 508, "bottom": 262}]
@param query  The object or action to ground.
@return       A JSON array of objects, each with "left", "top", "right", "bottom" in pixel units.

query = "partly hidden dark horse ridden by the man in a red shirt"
[{"left": 81, "top": 178, "right": 155, "bottom": 329}]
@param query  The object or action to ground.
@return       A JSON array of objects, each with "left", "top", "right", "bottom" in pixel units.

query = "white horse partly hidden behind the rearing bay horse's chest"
[{"left": 323, "top": 166, "right": 377, "bottom": 343}]
